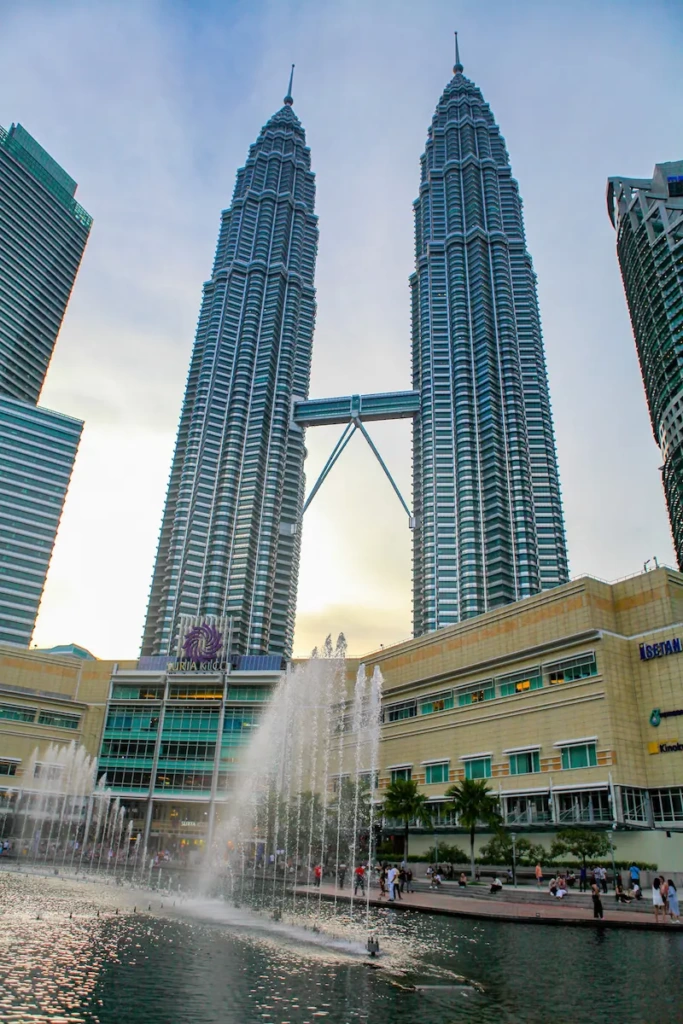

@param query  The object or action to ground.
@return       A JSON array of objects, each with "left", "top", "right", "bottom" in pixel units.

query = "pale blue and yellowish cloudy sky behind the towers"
[{"left": 0, "top": 0, "right": 683, "bottom": 658}]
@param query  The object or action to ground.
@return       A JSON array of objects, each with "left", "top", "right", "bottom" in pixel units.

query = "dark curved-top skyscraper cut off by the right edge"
[{"left": 607, "top": 160, "right": 683, "bottom": 568}]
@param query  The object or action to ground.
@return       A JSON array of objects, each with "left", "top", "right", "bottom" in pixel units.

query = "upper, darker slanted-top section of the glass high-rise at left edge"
[{"left": 0, "top": 125, "right": 92, "bottom": 404}]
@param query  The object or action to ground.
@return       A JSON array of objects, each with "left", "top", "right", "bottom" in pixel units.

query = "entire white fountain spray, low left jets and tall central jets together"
[{"left": 0, "top": 635, "right": 382, "bottom": 953}]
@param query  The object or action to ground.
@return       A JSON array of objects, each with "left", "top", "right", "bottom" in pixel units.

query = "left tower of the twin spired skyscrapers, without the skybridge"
[{"left": 142, "top": 81, "right": 317, "bottom": 655}]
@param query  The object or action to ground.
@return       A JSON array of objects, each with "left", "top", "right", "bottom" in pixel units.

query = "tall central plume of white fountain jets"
[{"left": 203, "top": 636, "right": 382, "bottom": 942}]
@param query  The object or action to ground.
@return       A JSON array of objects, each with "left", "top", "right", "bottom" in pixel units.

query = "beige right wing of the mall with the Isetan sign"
[{"left": 350, "top": 568, "right": 683, "bottom": 869}]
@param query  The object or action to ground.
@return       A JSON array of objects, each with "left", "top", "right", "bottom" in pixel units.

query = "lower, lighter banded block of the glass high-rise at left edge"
[{"left": 0, "top": 394, "right": 83, "bottom": 646}]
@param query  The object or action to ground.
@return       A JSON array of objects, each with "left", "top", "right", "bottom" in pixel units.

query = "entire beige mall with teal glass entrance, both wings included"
[{"left": 0, "top": 568, "right": 683, "bottom": 870}]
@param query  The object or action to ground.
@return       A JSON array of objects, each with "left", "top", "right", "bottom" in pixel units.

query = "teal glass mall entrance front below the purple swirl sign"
[{"left": 98, "top": 656, "right": 282, "bottom": 856}]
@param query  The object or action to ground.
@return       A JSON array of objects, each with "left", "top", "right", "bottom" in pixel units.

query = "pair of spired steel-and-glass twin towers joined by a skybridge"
[{"left": 142, "top": 53, "right": 567, "bottom": 656}]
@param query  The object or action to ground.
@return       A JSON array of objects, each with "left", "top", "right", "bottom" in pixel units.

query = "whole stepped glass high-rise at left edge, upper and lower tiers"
[{"left": 0, "top": 125, "right": 92, "bottom": 645}]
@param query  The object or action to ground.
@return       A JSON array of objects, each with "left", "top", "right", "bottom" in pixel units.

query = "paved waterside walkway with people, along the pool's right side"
[{"left": 296, "top": 885, "right": 683, "bottom": 932}]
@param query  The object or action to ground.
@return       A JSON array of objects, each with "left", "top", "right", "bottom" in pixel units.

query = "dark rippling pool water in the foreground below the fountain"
[{"left": 0, "top": 870, "right": 683, "bottom": 1024}]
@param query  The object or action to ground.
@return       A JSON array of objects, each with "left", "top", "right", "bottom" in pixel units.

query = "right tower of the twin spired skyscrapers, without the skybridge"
[{"left": 411, "top": 44, "right": 567, "bottom": 635}]
